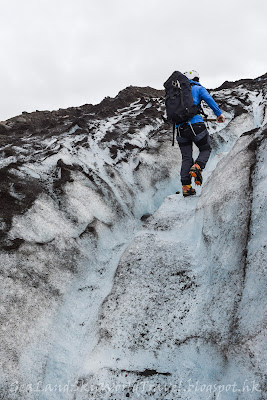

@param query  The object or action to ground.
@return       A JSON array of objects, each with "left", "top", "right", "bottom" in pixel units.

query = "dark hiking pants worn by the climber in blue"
[{"left": 177, "top": 122, "right": 211, "bottom": 185}]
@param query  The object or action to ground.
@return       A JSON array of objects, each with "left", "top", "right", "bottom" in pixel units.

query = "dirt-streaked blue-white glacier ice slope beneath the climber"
[{"left": 0, "top": 77, "right": 267, "bottom": 400}]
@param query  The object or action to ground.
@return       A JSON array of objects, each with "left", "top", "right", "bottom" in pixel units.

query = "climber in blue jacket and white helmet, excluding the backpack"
[{"left": 176, "top": 70, "right": 225, "bottom": 197}]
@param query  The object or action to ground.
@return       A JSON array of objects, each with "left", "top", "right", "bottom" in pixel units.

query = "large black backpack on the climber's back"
[{"left": 164, "top": 71, "right": 200, "bottom": 145}]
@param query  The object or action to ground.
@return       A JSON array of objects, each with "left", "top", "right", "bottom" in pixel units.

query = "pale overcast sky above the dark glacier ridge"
[{"left": 0, "top": 0, "right": 267, "bottom": 121}]
